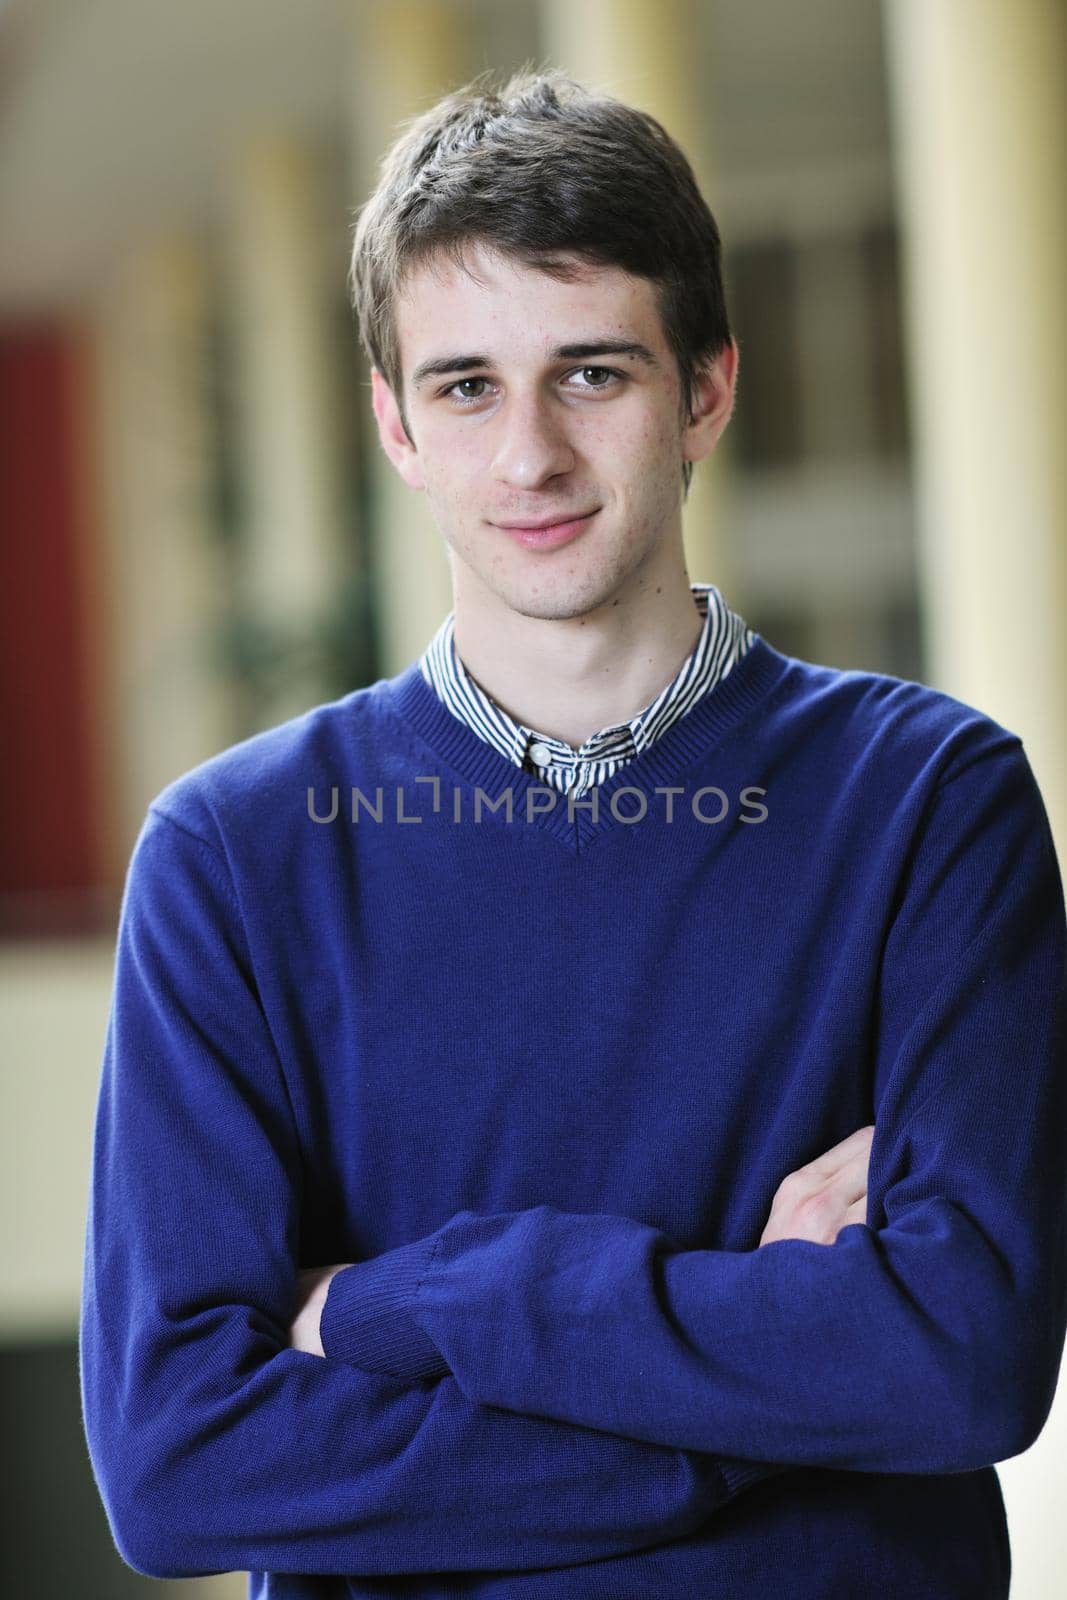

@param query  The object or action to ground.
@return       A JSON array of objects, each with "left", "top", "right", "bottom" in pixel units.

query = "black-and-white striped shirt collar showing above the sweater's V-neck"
[{"left": 419, "top": 584, "right": 757, "bottom": 798}]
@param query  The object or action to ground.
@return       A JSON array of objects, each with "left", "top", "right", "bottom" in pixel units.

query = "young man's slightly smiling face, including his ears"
[{"left": 374, "top": 245, "right": 736, "bottom": 619}]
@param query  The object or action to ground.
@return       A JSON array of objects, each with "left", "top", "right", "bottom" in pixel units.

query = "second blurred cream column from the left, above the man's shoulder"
[{"left": 227, "top": 133, "right": 346, "bottom": 725}]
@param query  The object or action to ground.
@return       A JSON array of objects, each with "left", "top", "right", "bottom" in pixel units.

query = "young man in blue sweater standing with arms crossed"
[{"left": 82, "top": 74, "right": 1067, "bottom": 1600}]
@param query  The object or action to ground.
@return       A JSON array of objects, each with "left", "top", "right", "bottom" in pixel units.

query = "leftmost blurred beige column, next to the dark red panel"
[{"left": 93, "top": 235, "right": 234, "bottom": 861}]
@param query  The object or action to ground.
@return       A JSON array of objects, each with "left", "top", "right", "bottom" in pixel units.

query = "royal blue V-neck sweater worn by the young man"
[{"left": 80, "top": 637, "right": 1067, "bottom": 1600}]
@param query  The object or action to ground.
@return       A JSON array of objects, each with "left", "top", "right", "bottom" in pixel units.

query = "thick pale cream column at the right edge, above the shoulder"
[{"left": 885, "top": 0, "right": 1067, "bottom": 861}]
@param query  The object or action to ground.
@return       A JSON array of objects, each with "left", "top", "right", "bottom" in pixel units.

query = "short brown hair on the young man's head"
[{"left": 349, "top": 67, "right": 731, "bottom": 491}]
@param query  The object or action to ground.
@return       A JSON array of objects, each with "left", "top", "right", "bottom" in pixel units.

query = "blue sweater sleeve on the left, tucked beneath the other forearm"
[{"left": 80, "top": 811, "right": 783, "bottom": 1578}]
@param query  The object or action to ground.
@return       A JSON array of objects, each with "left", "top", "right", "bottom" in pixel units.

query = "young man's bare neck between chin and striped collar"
[{"left": 454, "top": 565, "right": 702, "bottom": 749}]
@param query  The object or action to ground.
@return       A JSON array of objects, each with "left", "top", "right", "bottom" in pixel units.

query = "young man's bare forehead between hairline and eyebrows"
[{"left": 395, "top": 243, "right": 665, "bottom": 373}]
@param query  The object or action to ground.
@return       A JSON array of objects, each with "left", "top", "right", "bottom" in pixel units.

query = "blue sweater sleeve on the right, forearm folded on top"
[{"left": 316, "top": 736, "right": 1067, "bottom": 1474}]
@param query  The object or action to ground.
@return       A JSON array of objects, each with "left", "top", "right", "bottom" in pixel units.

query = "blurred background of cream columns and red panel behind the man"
[{"left": 0, "top": 0, "right": 1067, "bottom": 1600}]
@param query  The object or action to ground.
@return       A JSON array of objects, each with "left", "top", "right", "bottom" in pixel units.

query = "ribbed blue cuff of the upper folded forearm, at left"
[{"left": 318, "top": 1235, "right": 448, "bottom": 1379}]
